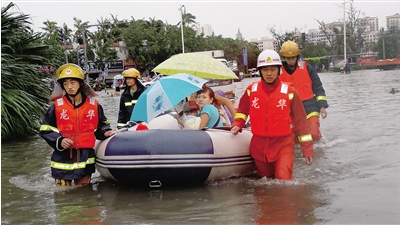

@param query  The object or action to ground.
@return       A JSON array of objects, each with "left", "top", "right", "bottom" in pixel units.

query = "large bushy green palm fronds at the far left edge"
[{"left": 1, "top": 3, "right": 54, "bottom": 142}]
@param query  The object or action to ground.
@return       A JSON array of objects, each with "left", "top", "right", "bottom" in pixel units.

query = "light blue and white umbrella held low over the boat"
[{"left": 131, "top": 73, "right": 207, "bottom": 122}]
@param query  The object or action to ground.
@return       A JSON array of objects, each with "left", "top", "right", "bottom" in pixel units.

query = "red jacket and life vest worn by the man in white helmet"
[{"left": 232, "top": 77, "right": 314, "bottom": 162}]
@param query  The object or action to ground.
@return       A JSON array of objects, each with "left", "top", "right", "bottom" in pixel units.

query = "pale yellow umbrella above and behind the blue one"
[{"left": 153, "top": 53, "right": 237, "bottom": 79}]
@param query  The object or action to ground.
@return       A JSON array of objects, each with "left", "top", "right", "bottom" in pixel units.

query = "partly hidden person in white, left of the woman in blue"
[{"left": 174, "top": 100, "right": 201, "bottom": 130}]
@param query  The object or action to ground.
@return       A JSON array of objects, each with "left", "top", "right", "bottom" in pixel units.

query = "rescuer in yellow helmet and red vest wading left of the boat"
[{"left": 39, "top": 64, "right": 113, "bottom": 186}]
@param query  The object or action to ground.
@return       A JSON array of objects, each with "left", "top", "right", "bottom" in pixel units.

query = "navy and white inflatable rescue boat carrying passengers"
[{"left": 95, "top": 114, "right": 256, "bottom": 187}]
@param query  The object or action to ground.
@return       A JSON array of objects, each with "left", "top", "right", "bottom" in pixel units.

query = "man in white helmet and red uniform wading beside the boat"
[{"left": 231, "top": 50, "right": 314, "bottom": 180}]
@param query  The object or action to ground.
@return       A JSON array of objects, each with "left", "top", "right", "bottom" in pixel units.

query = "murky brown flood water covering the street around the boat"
[{"left": 1, "top": 70, "right": 400, "bottom": 225}]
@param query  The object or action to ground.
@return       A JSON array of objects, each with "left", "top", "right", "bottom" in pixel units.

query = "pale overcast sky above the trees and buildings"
[{"left": 2, "top": 0, "right": 400, "bottom": 40}]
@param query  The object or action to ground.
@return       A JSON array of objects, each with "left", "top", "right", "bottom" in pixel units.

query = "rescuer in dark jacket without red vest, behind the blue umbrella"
[{"left": 117, "top": 68, "right": 146, "bottom": 129}]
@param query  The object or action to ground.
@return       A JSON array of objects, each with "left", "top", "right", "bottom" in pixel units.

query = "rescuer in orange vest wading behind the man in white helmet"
[{"left": 279, "top": 41, "right": 329, "bottom": 142}]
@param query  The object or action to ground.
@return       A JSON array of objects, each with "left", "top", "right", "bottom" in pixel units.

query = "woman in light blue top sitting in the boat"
[{"left": 197, "top": 86, "right": 222, "bottom": 129}]
